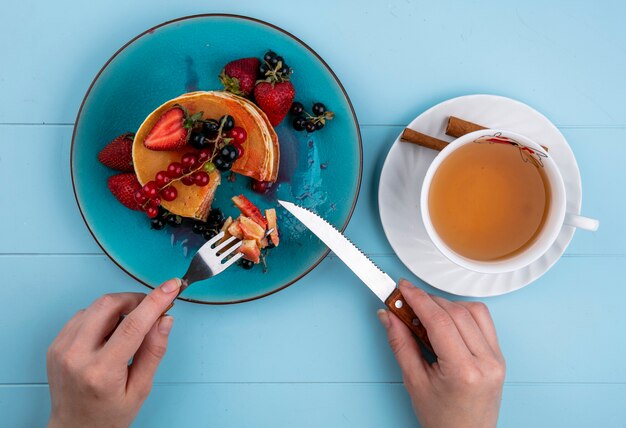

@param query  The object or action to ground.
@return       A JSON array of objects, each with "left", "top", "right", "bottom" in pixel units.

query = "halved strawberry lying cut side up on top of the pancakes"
[{"left": 143, "top": 104, "right": 202, "bottom": 150}]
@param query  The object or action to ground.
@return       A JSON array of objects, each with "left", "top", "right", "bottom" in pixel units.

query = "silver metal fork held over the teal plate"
[{"left": 165, "top": 228, "right": 274, "bottom": 300}]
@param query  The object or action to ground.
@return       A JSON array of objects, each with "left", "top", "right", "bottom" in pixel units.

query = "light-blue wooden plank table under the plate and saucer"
[{"left": 0, "top": 0, "right": 626, "bottom": 427}]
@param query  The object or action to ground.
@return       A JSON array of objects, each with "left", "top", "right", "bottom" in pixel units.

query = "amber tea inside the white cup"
[{"left": 428, "top": 142, "right": 550, "bottom": 261}]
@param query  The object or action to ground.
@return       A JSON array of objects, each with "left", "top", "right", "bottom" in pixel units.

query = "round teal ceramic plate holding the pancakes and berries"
[{"left": 71, "top": 15, "right": 362, "bottom": 304}]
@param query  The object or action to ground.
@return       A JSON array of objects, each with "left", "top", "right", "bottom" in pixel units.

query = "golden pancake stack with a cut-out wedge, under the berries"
[{"left": 133, "top": 92, "right": 280, "bottom": 220}]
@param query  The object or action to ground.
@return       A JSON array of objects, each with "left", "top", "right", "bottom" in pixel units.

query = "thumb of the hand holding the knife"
[{"left": 377, "top": 309, "right": 427, "bottom": 382}]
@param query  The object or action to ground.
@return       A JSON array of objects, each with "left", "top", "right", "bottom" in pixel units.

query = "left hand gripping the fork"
[{"left": 47, "top": 279, "right": 180, "bottom": 427}]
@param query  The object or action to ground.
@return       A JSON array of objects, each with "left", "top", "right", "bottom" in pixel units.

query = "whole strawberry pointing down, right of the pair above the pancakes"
[{"left": 254, "top": 51, "right": 296, "bottom": 126}]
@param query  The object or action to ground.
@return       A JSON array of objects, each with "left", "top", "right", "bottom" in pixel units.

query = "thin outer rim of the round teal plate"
[{"left": 70, "top": 13, "right": 363, "bottom": 305}]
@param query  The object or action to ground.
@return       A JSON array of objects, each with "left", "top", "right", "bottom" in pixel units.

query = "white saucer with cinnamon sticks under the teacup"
[{"left": 378, "top": 95, "right": 582, "bottom": 297}]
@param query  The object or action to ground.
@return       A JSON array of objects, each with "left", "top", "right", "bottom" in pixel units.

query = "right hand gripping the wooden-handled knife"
[{"left": 378, "top": 280, "right": 505, "bottom": 428}]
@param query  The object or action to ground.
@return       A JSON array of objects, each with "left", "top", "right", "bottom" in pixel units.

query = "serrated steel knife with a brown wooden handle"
[{"left": 278, "top": 200, "right": 432, "bottom": 351}]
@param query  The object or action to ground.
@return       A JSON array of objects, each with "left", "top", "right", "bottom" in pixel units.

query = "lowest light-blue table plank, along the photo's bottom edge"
[{"left": 0, "top": 383, "right": 626, "bottom": 428}]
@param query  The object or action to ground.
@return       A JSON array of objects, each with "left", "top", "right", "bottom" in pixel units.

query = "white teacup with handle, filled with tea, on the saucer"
[{"left": 420, "top": 129, "right": 599, "bottom": 273}]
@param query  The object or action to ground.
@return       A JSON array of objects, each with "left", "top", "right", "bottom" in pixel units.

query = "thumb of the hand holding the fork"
[{"left": 127, "top": 315, "right": 174, "bottom": 398}]
